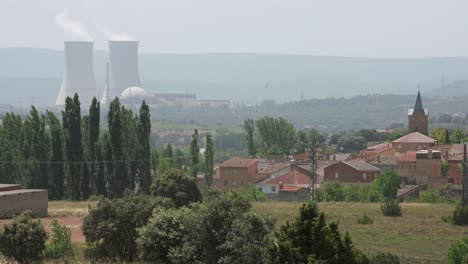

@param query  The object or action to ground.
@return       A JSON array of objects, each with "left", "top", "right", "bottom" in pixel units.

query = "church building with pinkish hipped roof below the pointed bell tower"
[{"left": 392, "top": 132, "right": 437, "bottom": 153}]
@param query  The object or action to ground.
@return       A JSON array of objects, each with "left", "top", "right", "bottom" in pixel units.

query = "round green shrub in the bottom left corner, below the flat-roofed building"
[{"left": 0, "top": 211, "right": 47, "bottom": 263}]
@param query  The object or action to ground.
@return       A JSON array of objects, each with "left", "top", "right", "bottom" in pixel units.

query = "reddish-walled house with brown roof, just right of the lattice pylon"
[{"left": 324, "top": 160, "right": 380, "bottom": 183}]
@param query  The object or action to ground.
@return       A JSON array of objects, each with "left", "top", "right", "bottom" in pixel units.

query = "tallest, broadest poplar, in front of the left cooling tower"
[{"left": 62, "top": 94, "right": 83, "bottom": 200}]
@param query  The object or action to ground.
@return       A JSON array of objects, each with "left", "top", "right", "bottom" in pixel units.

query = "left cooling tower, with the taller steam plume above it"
[{"left": 55, "top": 41, "right": 97, "bottom": 106}]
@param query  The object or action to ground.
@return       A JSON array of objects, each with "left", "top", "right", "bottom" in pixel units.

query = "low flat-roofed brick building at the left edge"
[{"left": 0, "top": 184, "right": 48, "bottom": 217}]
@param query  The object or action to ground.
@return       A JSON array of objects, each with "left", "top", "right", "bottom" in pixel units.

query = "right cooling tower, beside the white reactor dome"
[{"left": 101, "top": 41, "right": 141, "bottom": 105}]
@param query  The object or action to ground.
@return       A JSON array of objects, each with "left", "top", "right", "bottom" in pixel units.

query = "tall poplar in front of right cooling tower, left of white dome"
[{"left": 107, "top": 97, "right": 128, "bottom": 197}]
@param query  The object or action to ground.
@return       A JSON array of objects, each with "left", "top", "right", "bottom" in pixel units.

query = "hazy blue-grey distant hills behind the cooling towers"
[{"left": 0, "top": 48, "right": 468, "bottom": 105}]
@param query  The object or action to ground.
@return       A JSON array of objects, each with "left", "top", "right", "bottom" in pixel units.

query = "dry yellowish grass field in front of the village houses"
[{"left": 254, "top": 202, "right": 468, "bottom": 263}]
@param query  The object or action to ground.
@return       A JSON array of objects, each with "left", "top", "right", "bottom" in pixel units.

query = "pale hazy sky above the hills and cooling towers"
[{"left": 0, "top": 0, "right": 468, "bottom": 57}]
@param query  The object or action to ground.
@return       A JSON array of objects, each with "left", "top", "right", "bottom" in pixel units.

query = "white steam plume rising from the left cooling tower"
[{"left": 55, "top": 8, "right": 93, "bottom": 41}]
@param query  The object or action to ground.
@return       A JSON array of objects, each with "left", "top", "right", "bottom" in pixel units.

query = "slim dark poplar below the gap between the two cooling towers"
[{"left": 87, "top": 97, "right": 102, "bottom": 193}]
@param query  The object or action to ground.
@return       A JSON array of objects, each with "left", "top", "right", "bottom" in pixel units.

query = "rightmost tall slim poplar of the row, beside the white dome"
[{"left": 139, "top": 100, "right": 151, "bottom": 194}]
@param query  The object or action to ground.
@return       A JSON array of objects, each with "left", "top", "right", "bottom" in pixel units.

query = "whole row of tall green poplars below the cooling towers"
[{"left": 0, "top": 94, "right": 151, "bottom": 200}]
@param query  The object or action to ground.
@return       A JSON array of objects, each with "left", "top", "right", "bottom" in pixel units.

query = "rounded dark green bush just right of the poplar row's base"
[{"left": 151, "top": 169, "right": 202, "bottom": 207}]
